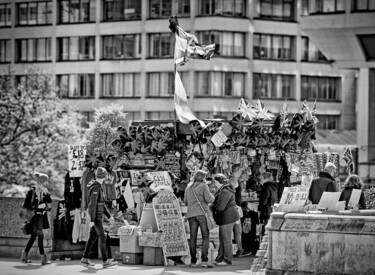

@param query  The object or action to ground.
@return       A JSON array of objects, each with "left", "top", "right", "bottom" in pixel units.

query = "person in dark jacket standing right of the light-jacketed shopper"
[{"left": 211, "top": 174, "right": 240, "bottom": 266}]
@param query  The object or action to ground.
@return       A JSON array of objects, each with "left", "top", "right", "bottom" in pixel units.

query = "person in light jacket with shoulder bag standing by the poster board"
[{"left": 184, "top": 170, "right": 215, "bottom": 267}]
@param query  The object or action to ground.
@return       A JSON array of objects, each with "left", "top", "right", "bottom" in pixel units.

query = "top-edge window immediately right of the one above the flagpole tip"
[{"left": 197, "top": 0, "right": 246, "bottom": 17}]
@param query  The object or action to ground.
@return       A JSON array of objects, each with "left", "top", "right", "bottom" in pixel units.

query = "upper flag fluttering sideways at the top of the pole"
[{"left": 169, "top": 16, "right": 215, "bottom": 65}]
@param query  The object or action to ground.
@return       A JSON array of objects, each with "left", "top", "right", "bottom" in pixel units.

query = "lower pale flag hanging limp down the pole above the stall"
[{"left": 174, "top": 71, "right": 206, "bottom": 128}]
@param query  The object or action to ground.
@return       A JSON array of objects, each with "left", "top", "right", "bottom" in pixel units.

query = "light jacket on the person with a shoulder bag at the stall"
[{"left": 184, "top": 182, "right": 215, "bottom": 218}]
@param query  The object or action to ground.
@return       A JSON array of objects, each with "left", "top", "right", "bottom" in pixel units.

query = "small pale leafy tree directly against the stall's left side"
[{"left": 87, "top": 103, "right": 128, "bottom": 158}]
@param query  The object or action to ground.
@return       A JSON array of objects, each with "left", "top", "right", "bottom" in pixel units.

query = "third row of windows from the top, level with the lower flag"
[{"left": 14, "top": 71, "right": 341, "bottom": 101}]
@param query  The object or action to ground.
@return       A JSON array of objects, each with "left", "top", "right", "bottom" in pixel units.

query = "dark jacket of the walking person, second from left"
[{"left": 87, "top": 180, "right": 111, "bottom": 221}]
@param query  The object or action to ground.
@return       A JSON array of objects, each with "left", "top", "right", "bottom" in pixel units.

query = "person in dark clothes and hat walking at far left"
[{"left": 21, "top": 172, "right": 52, "bottom": 265}]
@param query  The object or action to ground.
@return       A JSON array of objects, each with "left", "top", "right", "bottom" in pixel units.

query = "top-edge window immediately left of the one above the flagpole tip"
[{"left": 103, "top": 0, "right": 142, "bottom": 21}]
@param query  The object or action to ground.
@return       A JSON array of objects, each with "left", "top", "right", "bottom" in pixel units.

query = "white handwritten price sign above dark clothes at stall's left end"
[{"left": 68, "top": 145, "right": 86, "bottom": 178}]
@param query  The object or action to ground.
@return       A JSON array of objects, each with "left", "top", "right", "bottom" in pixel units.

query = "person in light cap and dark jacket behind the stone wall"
[{"left": 309, "top": 162, "right": 337, "bottom": 204}]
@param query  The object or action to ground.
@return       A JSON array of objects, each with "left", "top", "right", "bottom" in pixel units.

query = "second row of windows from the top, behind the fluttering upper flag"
[{"left": 0, "top": 31, "right": 326, "bottom": 63}]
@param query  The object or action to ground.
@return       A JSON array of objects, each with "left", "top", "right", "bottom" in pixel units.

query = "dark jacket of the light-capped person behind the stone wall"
[{"left": 309, "top": 171, "right": 337, "bottom": 204}]
